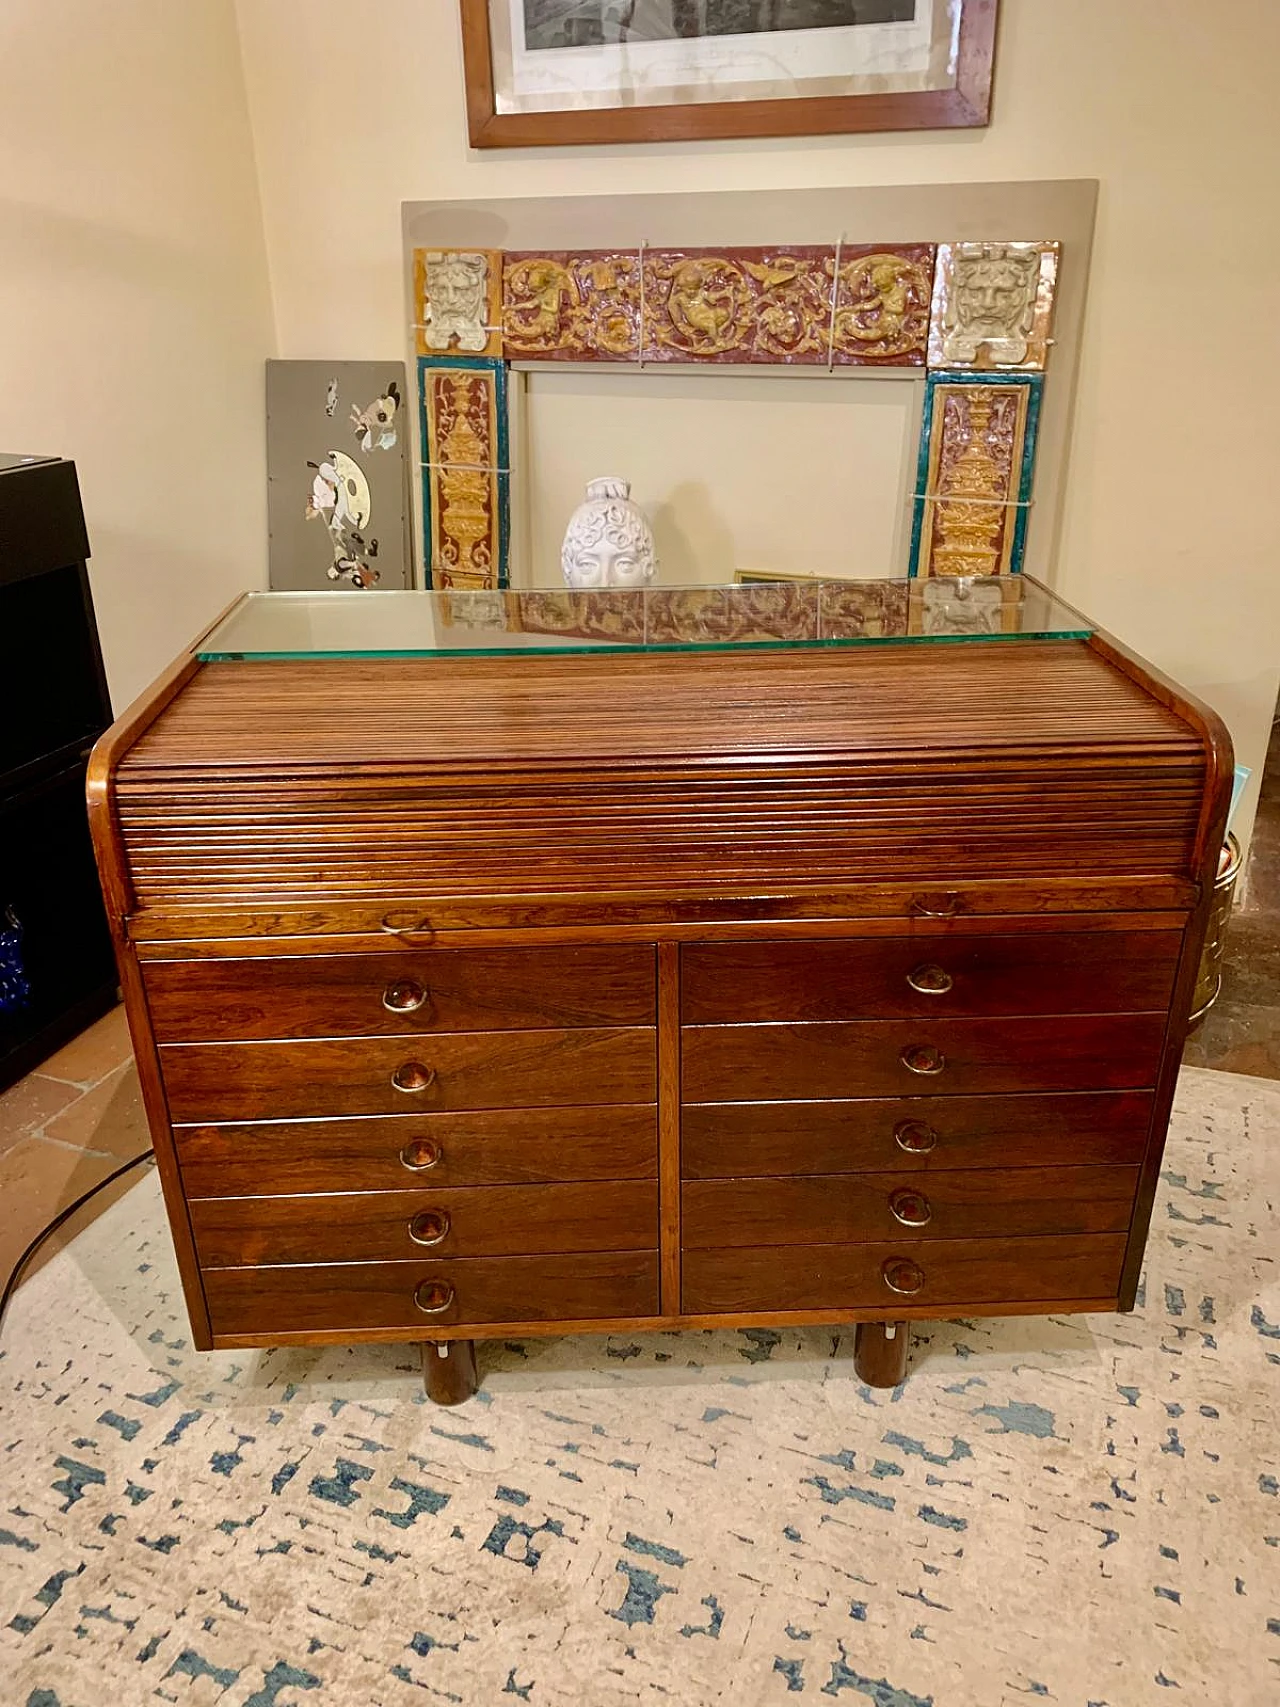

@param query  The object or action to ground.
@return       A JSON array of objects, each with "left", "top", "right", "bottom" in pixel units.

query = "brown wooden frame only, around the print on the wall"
[{"left": 459, "top": 0, "right": 998, "bottom": 149}]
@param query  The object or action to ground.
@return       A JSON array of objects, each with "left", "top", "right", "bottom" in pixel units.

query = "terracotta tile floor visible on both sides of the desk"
[{"left": 0, "top": 727, "right": 1280, "bottom": 1304}]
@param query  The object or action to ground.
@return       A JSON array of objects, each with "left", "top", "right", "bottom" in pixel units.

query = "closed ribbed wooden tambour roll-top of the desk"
[{"left": 118, "top": 642, "right": 1205, "bottom": 910}]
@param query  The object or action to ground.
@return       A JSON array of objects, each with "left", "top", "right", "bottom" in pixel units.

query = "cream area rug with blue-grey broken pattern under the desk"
[{"left": 0, "top": 1072, "right": 1280, "bottom": 1707}]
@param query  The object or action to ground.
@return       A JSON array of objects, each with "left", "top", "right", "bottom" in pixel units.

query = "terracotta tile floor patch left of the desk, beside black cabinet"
[{"left": 0, "top": 1007, "right": 150, "bottom": 1284}]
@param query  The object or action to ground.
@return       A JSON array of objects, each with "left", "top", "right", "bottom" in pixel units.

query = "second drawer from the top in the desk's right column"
[{"left": 681, "top": 1014, "right": 1164, "bottom": 1103}]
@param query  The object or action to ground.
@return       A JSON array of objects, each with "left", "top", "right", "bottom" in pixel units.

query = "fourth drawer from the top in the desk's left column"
[{"left": 189, "top": 1180, "right": 657, "bottom": 1268}]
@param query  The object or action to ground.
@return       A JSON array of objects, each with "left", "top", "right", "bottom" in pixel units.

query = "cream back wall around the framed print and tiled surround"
[{"left": 237, "top": 0, "right": 1280, "bottom": 843}]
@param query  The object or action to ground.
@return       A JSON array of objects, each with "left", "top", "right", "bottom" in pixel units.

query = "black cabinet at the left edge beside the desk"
[{"left": 0, "top": 456, "right": 118, "bottom": 1089}]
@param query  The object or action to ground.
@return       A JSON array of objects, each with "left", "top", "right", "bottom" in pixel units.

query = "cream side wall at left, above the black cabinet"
[{"left": 0, "top": 0, "right": 275, "bottom": 708}]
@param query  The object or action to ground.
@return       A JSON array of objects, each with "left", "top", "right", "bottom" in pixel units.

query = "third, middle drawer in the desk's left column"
[{"left": 174, "top": 1104, "right": 657, "bottom": 1197}]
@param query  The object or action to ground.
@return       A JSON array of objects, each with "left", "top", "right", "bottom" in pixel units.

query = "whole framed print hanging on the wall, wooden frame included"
[{"left": 459, "top": 0, "right": 998, "bottom": 149}]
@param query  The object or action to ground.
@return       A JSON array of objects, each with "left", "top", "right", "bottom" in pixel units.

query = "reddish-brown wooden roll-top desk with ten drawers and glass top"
[{"left": 90, "top": 579, "right": 1231, "bottom": 1401}]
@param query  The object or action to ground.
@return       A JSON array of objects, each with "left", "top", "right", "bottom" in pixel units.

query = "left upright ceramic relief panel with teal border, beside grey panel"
[{"left": 418, "top": 357, "right": 510, "bottom": 591}]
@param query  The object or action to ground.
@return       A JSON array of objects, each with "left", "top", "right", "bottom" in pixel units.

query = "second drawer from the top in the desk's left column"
[{"left": 160, "top": 1029, "right": 655, "bottom": 1125}]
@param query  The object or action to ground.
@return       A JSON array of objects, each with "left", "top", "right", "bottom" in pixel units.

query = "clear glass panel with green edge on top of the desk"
[{"left": 198, "top": 575, "right": 1092, "bottom": 661}]
